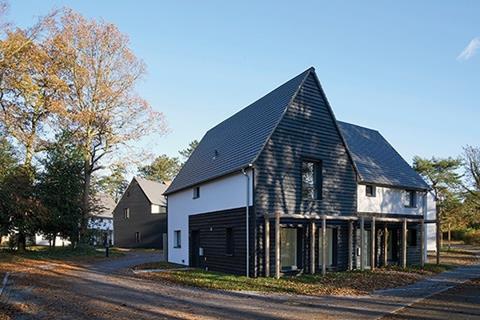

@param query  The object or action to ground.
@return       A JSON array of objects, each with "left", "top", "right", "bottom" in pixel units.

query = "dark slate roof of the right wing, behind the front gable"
[{"left": 337, "top": 121, "right": 428, "bottom": 189}]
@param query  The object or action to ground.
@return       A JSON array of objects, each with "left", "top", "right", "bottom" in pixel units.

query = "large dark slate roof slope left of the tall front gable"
[{"left": 165, "top": 68, "right": 314, "bottom": 195}]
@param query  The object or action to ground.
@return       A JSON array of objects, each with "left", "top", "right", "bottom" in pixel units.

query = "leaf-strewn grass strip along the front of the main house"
[{"left": 141, "top": 265, "right": 449, "bottom": 296}]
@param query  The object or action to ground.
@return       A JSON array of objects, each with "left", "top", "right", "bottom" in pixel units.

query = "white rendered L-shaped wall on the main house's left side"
[{"left": 167, "top": 170, "right": 253, "bottom": 265}]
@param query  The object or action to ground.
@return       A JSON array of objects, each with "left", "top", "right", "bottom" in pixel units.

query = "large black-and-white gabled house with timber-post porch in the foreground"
[{"left": 165, "top": 68, "right": 436, "bottom": 277}]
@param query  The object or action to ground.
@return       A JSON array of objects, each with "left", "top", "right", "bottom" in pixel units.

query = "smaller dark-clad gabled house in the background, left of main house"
[{"left": 113, "top": 177, "right": 167, "bottom": 249}]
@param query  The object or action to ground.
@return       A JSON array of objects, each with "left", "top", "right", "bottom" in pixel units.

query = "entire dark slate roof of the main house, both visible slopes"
[{"left": 164, "top": 68, "right": 428, "bottom": 195}]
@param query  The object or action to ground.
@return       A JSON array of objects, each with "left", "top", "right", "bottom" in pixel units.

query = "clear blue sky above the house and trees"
[{"left": 10, "top": 0, "right": 480, "bottom": 168}]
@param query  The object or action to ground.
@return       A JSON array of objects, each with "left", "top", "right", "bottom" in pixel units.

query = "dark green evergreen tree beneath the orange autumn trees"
[{"left": 37, "top": 134, "right": 83, "bottom": 245}]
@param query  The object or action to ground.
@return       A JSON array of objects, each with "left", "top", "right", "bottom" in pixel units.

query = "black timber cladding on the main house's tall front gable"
[{"left": 255, "top": 73, "right": 356, "bottom": 215}]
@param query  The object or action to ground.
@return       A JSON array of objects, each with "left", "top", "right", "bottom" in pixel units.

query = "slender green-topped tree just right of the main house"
[{"left": 413, "top": 157, "right": 461, "bottom": 264}]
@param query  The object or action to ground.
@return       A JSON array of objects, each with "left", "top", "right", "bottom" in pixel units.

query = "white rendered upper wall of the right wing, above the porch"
[{"left": 357, "top": 184, "right": 424, "bottom": 214}]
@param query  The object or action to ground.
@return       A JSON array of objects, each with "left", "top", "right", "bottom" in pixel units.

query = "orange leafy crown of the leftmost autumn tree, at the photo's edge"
[{"left": 0, "top": 9, "right": 66, "bottom": 166}]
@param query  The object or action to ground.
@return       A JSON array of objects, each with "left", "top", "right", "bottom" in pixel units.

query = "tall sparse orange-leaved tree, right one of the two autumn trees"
[{"left": 50, "top": 10, "right": 166, "bottom": 240}]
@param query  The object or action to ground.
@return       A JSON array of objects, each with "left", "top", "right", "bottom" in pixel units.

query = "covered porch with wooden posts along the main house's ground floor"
[{"left": 257, "top": 214, "right": 425, "bottom": 278}]
